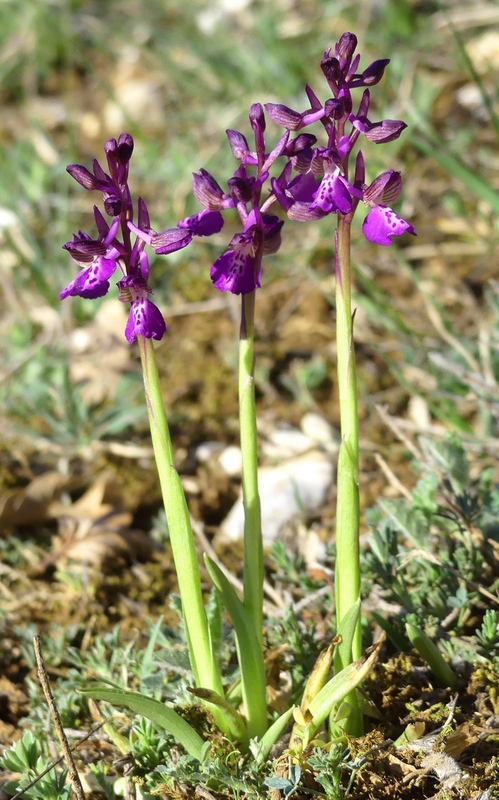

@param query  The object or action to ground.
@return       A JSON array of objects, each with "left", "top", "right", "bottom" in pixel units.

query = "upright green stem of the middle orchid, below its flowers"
[{"left": 239, "top": 291, "right": 263, "bottom": 646}]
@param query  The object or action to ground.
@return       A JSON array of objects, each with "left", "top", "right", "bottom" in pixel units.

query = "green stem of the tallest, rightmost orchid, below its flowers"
[{"left": 335, "top": 214, "right": 362, "bottom": 670}]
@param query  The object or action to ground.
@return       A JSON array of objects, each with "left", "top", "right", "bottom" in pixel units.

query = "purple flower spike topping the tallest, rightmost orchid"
[{"left": 265, "top": 33, "right": 416, "bottom": 246}]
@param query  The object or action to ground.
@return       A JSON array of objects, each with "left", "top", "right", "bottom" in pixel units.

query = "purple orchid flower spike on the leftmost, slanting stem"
[{"left": 60, "top": 133, "right": 192, "bottom": 344}]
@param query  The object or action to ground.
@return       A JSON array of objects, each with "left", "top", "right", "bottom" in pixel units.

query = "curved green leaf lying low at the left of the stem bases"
[{"left": 79, "top": 687, "right": 204, "bottom": 761}]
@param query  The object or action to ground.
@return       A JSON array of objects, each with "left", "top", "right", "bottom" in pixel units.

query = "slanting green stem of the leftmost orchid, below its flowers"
[{"left": 137, "top": 336, "right": 228, "bottom": 733}]
